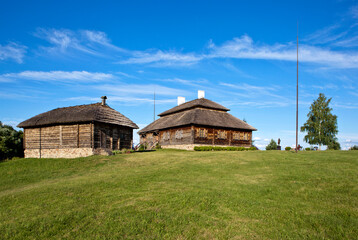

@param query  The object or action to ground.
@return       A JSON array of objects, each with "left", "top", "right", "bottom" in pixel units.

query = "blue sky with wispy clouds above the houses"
[{"left": 0, "top": 0, "right": 358, "bottom": 149}]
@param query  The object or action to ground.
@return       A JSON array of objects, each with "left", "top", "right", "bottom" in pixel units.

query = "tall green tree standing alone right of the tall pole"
[{"left": 301, "top": 93, "right": 338, "bottom": 149}]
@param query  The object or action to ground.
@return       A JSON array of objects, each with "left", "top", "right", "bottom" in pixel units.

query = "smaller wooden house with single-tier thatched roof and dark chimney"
[{"left": 18, "top": 97, "right": 138, "bottom": 158}]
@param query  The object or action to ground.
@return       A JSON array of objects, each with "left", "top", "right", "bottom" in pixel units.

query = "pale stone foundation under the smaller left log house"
[{"left": 25, "top": 148, "right": 105, "bottom": 158}]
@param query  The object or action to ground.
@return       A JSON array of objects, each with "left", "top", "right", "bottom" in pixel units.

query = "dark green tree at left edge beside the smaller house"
[{"left": 0, "top": 121, "right": 24, "bottom": 160}]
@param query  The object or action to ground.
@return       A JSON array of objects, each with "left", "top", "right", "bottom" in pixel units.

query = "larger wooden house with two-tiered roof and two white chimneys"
[{"left": 138, "top": 91, "right": 257, "bottom": 150}]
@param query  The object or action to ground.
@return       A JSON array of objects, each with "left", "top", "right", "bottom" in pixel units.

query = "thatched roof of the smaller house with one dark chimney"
[{"left": 18, "top": 103, "right": 138, "bottom": 129}]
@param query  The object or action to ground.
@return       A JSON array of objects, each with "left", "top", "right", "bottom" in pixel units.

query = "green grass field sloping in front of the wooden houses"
[{"left": 0, "top": 150, "right": 358, "bottom": 239}]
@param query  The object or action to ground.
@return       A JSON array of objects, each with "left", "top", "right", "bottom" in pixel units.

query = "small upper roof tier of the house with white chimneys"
[{"left": 158, "top": 98, "right": 230, "bottom": 117}]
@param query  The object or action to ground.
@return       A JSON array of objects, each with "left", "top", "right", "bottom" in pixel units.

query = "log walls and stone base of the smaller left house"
[{"left": 24, "top": 123, "right": 133, "bottom": 158}]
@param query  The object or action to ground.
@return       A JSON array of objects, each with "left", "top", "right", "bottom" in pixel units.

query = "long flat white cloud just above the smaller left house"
[{"left": 0, "top": 71, "right": 114, "bottom": 83}]
